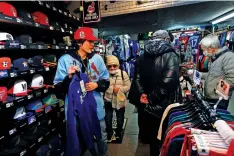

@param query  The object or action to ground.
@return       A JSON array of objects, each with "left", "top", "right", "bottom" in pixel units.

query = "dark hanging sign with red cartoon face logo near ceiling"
[{"left": 82, "top": 0, "right": 101, "bottom": 23}]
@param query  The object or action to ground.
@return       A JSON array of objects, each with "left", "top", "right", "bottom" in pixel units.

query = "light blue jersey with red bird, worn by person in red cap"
[{"left": 54, "top": 51, "right": 109, "bottom": 120}]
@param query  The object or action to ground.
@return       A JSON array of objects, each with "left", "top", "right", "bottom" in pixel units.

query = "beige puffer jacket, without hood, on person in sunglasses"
[{"left": 104, "top": 69, "right": 131, "bottom": 108}]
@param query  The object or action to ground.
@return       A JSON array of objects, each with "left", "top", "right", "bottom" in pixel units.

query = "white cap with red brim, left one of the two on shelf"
[{"left": 8, "top": 80, "right": 31, "bottom": 96}]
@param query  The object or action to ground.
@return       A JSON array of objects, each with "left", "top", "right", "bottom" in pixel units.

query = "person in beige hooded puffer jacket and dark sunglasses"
[{"left": 104, "top": 55, "right": 131, "bottom": 142}]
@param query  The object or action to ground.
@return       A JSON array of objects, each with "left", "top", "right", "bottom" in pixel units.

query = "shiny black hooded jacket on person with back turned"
[{"left": 133, "top": 40, "right": 181, "bottom": 117}]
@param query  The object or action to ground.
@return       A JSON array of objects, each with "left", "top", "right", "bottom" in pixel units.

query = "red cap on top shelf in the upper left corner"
[{"left": 0, "top": 2, "right": 17, "bottom": 17}]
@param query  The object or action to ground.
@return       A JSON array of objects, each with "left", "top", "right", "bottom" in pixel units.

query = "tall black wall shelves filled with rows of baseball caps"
[{"left": 0, "top": 1, "right": 81, "bottom": 156}]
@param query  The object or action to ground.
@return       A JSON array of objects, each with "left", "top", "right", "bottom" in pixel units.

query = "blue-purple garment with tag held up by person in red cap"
[{"left": 66, "top": 73, "right": 101, "bottom": 156}]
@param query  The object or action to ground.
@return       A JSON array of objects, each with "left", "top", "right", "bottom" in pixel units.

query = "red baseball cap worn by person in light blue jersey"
[{"left": 74, "top": 27, "right": 99, "bottom": 41}]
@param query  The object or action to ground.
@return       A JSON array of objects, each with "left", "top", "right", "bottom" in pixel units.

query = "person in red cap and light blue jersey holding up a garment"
[{"left": 54, "top": 27, "right": 110, "bottom": 156}]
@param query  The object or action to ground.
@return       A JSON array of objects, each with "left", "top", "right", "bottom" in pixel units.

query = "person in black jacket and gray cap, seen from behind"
[{"left": 132, "top": 30, "right": 181, "bottom": 156}]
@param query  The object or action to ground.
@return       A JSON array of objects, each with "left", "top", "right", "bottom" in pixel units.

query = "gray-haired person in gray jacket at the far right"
[{"left": 200, "top": 35, "right": 234, "bottom": 109}]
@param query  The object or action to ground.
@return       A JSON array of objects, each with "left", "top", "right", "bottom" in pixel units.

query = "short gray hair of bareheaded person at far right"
[{"left": 200, "top": 35, "right": 221, "bottom": 49}]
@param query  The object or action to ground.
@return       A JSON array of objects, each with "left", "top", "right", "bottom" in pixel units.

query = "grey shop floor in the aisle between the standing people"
[{"left": 85, "top": 104, "right": 149, "bottom": 156}]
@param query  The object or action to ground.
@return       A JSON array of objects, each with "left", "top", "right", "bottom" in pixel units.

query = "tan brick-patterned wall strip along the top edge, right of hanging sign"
[{"left": 100, "top": 0, "right": 199, "bottom": 17}]
